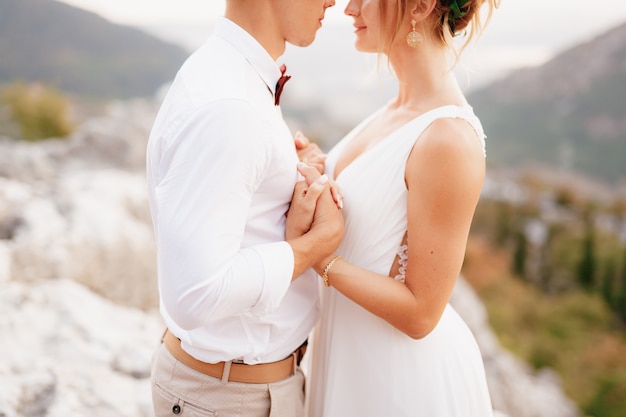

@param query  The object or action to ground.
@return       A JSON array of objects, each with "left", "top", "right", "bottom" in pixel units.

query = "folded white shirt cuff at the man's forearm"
[{"left": 250, "top": 242, "right": 294, "bottom": 316}]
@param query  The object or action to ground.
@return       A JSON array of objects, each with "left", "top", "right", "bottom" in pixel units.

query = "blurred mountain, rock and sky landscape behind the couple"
[{"left": 0, "top": 0, "right": 626, "bottom": 417}]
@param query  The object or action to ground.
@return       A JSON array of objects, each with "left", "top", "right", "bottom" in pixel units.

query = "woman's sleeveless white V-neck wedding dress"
[{"left": 307, "top": 106, "right": 493, "bottom": 417}]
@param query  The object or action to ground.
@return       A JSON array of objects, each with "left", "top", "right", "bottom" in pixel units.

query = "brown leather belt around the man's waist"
[{"left": 163, "top": 330, "right": 306, "bottom": 384}]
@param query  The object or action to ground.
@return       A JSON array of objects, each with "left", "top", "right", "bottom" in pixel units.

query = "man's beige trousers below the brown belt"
[{"left": 152, "top": 344, "right": 304, "bottom": 417}]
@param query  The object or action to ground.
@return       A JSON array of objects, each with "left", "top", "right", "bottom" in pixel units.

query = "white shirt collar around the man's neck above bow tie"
[{"left": 214, "top": 17, "right": 281, "bottom": 94}]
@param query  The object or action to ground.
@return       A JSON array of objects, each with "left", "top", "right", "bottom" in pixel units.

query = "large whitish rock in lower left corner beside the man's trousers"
[{"left": 0, "top": 280, "right": 163, "bottom": 417}]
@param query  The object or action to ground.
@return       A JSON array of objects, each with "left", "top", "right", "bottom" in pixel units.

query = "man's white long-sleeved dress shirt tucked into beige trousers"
[{"left": 147, "top": 18, "right": 318, "bottom": 364}]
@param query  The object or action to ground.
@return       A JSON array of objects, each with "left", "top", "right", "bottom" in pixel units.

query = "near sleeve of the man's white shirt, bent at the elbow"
[{"left": 155, "top": 99, "right": 294, "bottom": 330}]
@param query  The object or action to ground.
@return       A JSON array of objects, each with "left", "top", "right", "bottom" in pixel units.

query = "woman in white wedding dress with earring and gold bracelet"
[{"left": 290, "top": 0, "right": 499, "bottom": 417}]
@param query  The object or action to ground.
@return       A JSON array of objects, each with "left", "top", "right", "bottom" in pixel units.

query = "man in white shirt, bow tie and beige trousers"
[{"left": 147, "top": 0, "right": 343, "bottom": 417}]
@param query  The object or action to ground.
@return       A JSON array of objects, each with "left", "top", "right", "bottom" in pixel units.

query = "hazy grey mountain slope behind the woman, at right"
[{"left": 468, "top": 24, "right": 626, "bottom": 183}]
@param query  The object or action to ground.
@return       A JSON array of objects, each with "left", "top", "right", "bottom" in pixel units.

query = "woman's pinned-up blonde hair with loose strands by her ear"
[{"left": 378, "top": 0, "right": 501, "bottom": 56}]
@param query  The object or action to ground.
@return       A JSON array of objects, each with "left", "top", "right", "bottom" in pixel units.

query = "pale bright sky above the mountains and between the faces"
[{"left": 60, "top": 0, "right": 626, "bottom": 83}]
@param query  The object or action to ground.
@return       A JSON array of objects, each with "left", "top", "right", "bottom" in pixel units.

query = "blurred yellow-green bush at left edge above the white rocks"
[{"left": 2, "top": 82, "right": 73, "bottom": 141}]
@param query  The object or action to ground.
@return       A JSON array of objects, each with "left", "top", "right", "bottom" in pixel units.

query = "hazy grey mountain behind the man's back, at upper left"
[{"left": 0, "top": 0, "right": 187, "bottom": 98}]
